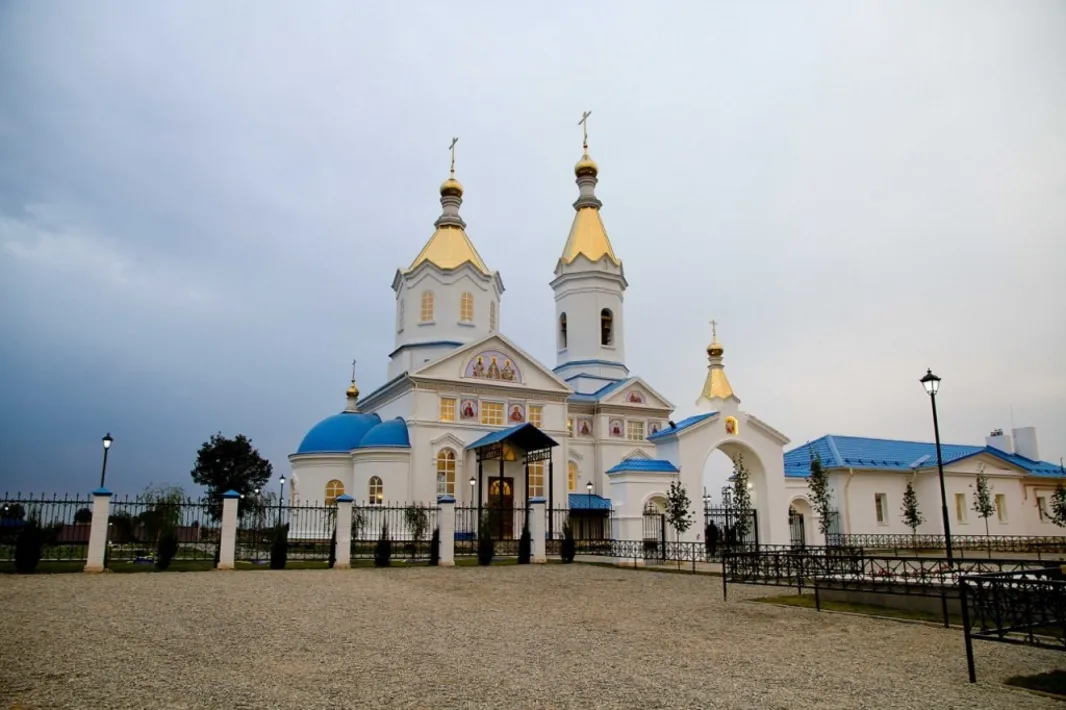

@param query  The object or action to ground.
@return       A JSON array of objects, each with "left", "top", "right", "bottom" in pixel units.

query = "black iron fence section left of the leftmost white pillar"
[{"left": 0, "top": 493, "right": 93, "bottom": 563}]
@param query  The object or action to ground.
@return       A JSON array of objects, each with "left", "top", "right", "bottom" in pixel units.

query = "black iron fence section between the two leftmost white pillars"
[{"left": 108, "top": 495, "right": 221, "bottom": 564}]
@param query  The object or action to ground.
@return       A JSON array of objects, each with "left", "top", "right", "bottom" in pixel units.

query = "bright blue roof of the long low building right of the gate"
[{"left": 785, "top": 434, "right": 1063, "bottom": 478}]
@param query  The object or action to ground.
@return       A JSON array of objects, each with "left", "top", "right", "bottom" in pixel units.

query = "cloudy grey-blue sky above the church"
[{"left": 0, "top": 0, "right": 1066, "bottom": 491}]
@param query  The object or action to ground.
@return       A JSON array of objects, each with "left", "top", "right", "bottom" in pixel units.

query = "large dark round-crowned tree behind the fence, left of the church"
[{"left": 192, "top": 432, "right": 274, "bottom": 520}]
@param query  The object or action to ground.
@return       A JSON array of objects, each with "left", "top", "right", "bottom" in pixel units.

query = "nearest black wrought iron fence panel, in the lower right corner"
[{"left": 959, "top": 567, "right": 1066, "bottom": 683}]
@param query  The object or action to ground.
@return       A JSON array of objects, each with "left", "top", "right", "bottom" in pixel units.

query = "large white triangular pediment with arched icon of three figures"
[{"left": 410, "top": 333, "right": 574, "bottom": 394}]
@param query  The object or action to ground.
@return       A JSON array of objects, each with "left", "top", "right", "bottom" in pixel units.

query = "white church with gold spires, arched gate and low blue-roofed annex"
[{"left": 289, "top": 135, "right": 1061, "bottom": 545}]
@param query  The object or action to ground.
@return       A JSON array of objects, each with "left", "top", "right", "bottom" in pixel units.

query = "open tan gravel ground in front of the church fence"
[{"left": 0, "top": 565, "right": 1064, "bottom": 710}]
